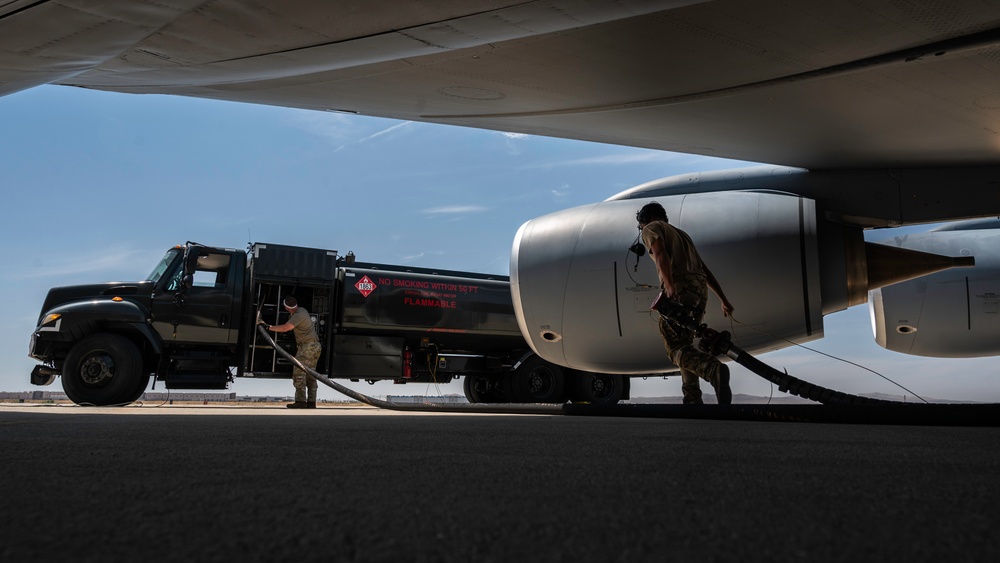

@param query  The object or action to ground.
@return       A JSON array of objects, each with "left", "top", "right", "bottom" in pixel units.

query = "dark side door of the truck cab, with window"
[{"left": 152, "top": 248, "right": 242, "bottom": 344}]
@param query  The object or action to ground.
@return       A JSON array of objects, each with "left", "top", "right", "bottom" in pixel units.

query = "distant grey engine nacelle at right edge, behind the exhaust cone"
[{"left": 869, "top": 219, "right": 1000, "bottom": 358}]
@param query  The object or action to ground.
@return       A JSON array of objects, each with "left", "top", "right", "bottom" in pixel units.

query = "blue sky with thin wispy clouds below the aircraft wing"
[{"left": 0, "top": 86, "right": 1000, "bottom": 401}]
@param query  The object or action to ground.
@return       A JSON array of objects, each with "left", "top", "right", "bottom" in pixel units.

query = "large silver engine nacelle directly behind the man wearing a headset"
[{"left": 511, "top": 192, "right": 824, "bottom": 374}]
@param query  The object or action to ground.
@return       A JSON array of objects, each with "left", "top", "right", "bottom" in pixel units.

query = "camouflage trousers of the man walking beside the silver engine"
[{"left": 660, "top": 274, "right": 722, "bottom": 405}]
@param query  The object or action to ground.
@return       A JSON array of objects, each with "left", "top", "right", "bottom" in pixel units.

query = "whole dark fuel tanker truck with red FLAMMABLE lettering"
[{"left": 29, "top": 242, "right": 629, "bottom": 405}]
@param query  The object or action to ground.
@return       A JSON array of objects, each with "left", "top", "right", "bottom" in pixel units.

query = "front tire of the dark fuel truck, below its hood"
[{"left": 62, "top": 333, "right": 149, "bottom": 406}]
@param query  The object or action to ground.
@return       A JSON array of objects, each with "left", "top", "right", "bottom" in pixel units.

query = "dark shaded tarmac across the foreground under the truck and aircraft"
[{"left": 0, "top": 404, "right": 1000, "bottom": 563}]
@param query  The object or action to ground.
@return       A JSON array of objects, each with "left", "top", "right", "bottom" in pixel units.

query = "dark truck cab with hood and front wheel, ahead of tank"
[{"left": 29, "top": 243, "right": 247, "bottom": 405}]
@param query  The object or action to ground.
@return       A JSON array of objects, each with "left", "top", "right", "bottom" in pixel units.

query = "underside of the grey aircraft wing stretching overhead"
[{"left": 0, "top": 0, "right": 1000, "bottom": 169}]
